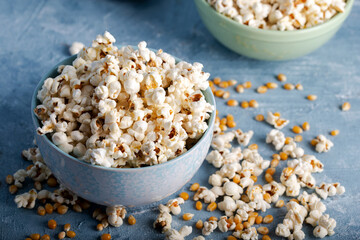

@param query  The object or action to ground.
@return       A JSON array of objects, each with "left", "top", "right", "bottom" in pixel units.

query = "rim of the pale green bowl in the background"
[{"left": 195, "top": 0, "right": 355, "bottom": 37}]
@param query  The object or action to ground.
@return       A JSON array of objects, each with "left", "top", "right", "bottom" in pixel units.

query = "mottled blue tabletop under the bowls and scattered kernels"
[{"left": 0, "top": 0, "right": 360, "bottom": 239}]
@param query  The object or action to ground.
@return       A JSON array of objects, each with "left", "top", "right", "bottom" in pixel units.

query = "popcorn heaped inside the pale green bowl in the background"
[{"left": 207, "top": 0, "right": 346, "bottom": 31}]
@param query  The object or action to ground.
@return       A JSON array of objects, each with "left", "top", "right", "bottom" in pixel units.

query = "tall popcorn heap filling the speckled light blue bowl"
[{"left": 34, "top": 32, "right": 213, "bottom": 167}]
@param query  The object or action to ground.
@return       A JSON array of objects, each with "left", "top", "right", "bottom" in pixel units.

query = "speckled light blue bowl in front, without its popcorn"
[{"left": 31, "top": 53, "right": 215, "bottom": 207}]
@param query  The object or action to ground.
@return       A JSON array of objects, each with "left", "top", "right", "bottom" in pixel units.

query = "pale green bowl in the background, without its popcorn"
[{"left": 195, "top": 0, "right": 354, "bottom": 60}]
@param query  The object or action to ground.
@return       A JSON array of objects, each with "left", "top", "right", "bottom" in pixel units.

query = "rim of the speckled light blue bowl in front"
[{"left": 31, "top": 49, "right": 216, "bottom": 172}]
